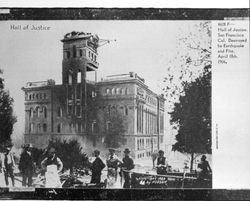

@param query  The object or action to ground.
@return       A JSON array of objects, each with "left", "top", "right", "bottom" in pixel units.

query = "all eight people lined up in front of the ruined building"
[{"left": 0, "top": 144, "right": 212, "bottom": 188}]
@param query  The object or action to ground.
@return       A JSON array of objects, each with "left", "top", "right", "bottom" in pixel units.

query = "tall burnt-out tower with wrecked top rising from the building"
[{"left": 61, "top": 31, "right": 99, "bottom": 130}]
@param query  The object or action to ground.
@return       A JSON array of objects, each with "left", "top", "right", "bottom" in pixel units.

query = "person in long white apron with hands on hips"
[{"left": 41, "top": 147, "right": 63, "bottom": 188}]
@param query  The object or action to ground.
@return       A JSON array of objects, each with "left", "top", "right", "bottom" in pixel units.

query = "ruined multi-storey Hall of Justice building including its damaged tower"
[{"left": 22, "top": 32, "right": 164, "bottom": 159}]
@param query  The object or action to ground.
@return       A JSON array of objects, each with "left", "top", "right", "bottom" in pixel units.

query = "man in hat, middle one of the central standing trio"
[{"left": 106, "top": 148, "right": 121, "bottom": 186}]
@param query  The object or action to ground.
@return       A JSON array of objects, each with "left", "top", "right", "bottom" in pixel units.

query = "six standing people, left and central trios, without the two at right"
[{"left": 0, "top": 144, "right": 134, "bottom": 188}]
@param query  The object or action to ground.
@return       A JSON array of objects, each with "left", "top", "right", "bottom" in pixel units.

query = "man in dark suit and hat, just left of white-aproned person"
[{"left": 19, "top": 144, "right": 35, "bottom": 187}]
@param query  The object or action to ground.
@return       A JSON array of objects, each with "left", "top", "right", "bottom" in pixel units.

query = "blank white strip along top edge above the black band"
[{"left": 0, "top": 0, "right": 249, "bottom": 8}]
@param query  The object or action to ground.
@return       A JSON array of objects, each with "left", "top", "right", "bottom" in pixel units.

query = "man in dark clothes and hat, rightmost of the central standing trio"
[{"left": 121, "top": 148, "right": 135, "bottom": 188}]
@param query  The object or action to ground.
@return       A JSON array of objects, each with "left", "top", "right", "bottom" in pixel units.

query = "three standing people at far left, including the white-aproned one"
[{"left": 1, "top": 144, "right": 63, "bottom": 187}]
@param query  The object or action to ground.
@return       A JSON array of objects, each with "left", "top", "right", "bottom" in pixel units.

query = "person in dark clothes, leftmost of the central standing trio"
[{"left": 90, "top": 150, "right": 105, "bottom": 184}]
